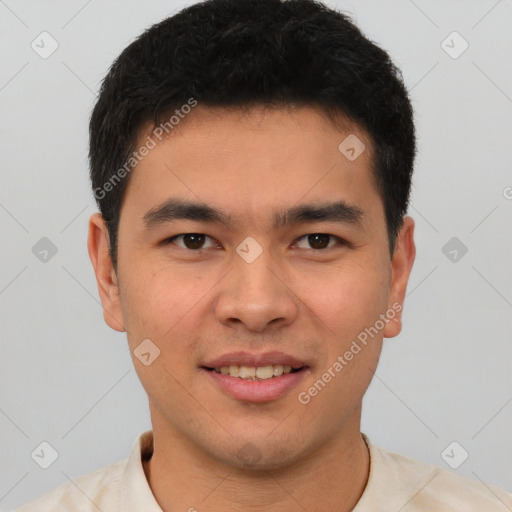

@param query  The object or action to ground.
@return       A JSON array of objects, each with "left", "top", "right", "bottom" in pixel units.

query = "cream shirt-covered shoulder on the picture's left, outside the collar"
[{"left": 14, "top": 459, "right": 127, "bottom": 512}]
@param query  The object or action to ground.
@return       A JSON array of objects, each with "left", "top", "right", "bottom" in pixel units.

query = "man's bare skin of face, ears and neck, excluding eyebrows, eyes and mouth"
[{"left": 88, "top": 105, "right": 415, "bottom": 512}]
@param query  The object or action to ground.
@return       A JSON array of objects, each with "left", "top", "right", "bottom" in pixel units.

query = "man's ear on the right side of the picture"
[{"left": 383, "top": 217, "right": 416, "bottom": 338}]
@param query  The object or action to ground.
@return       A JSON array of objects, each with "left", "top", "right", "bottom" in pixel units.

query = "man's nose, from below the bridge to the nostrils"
[{"left": 215, "top": 251, "right": 299, "bottom": 333}]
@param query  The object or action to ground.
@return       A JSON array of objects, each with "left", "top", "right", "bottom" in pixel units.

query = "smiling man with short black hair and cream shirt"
[{"left": 15, "top": 0, "right": 512, "bottom": 512}]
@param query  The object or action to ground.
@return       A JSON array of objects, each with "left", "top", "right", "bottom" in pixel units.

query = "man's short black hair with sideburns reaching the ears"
[{"left": 89, "top": 0, "right": 416, "bottom": 270}]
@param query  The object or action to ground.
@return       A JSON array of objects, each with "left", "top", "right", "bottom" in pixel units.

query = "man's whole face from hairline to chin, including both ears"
[{"left": 89, "top": 105, "right": 414, "bottom": 468}]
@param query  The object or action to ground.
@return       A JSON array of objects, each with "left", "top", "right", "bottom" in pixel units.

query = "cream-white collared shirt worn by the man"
[{"left": 16, "top": 430, "right": 512, "bottom": 512}]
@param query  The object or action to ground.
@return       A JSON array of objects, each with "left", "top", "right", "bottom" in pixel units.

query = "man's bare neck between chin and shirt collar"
[{"left": 144, "top": 416, "right": 370, "bottom": 512}]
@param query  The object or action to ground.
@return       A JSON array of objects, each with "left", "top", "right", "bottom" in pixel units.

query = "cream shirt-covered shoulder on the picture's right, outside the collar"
[{"left": 370, "top": 445, "right": 512, "bottom": 512}]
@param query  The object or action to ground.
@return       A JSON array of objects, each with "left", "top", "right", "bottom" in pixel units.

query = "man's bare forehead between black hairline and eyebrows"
[{"left": 124, "top": 105, "right": 379, "bottom": 229}]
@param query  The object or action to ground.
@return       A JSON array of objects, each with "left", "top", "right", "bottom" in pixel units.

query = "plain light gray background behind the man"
[{"left": 0, "top": 0, "right": 512, "bottom": 510}]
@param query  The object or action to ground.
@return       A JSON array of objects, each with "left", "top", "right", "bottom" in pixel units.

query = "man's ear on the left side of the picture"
[{"left": 87, "top": 213, "right": 126, "bottom": 332}]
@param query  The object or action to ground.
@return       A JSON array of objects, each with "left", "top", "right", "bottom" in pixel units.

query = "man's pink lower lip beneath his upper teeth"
[{"left": 201, "top": 367, "right": 307, "bottom": 403}]
